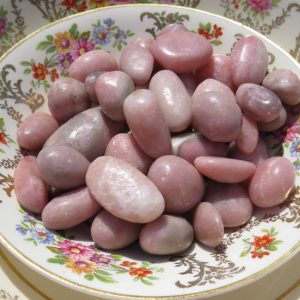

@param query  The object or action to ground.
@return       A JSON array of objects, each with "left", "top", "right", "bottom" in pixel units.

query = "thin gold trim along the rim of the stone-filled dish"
[{"left": 0, "top": 4, "right": 300, "bottom": 300}]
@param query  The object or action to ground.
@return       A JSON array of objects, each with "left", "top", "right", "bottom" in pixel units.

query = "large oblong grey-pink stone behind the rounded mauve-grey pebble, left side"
[{"left": 44, "top": 107, "right": 125, "bottom": 161}]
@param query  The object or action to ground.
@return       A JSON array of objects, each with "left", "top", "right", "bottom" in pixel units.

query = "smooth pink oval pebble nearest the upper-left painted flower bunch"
[{"left": 69, "top": 50, "right": 118, "bottom": 82}]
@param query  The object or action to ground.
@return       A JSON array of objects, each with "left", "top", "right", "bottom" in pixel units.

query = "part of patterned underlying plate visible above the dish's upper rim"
[{"left": 0, "top": 0, "right": 300, "bottom": 62}]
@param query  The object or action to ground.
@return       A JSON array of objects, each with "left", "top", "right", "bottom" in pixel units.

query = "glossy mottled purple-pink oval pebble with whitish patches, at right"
[{"left": 236, "top": 83, "right": 282, "bottom": 122}]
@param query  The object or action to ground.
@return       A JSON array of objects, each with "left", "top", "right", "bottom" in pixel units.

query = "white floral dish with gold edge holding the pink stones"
[{"left": 0, "top": 5, "right": 300, "bottom": 299}]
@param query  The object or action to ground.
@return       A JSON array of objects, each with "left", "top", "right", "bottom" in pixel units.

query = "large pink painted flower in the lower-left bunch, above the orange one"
[{"left": 57, "top": 240, "right": 93, "bottom": 260}]
